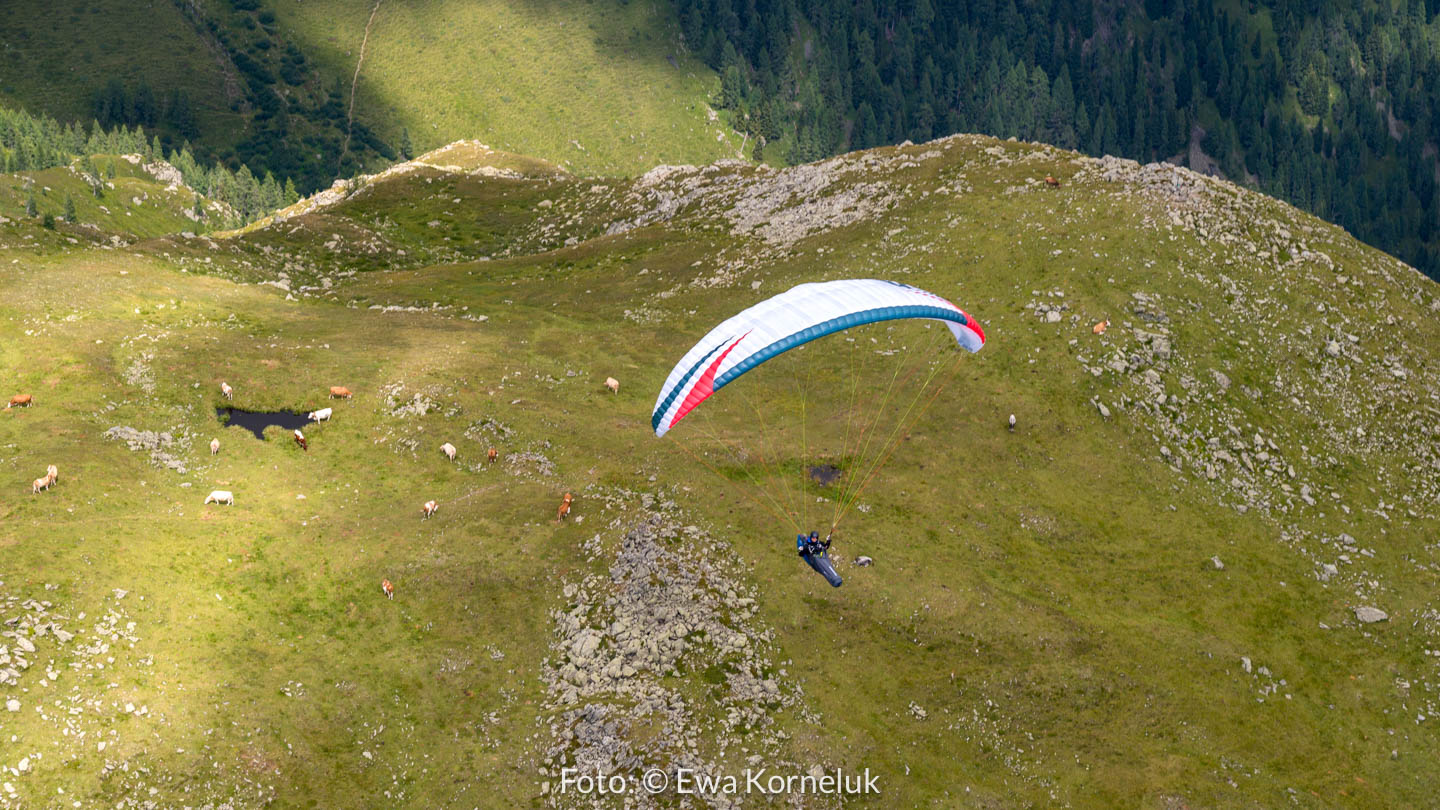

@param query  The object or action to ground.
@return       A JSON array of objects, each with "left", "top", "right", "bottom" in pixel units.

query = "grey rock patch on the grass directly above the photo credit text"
[{"left": 541, "top": 496, "right": 799, "bottom": 807}]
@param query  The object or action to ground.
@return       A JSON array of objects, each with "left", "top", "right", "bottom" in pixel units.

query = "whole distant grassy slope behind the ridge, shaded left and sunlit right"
[{"left": 0, "top": 0, "right": 742, "bottom": 190}]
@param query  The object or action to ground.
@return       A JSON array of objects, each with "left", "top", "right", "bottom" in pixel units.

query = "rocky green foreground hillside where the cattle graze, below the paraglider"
[{"left": 0, "top": 137, "right": 1440, "bottom": 807}]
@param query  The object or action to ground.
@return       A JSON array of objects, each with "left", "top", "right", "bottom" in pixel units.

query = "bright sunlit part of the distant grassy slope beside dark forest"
[{"left": 266, "top": 0, "right": 740, "bottom": 174}]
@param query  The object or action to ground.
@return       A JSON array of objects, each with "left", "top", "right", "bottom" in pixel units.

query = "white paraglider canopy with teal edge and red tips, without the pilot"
[{"left": 649, "top": 278, "right": 985, "bottom": 435}]
